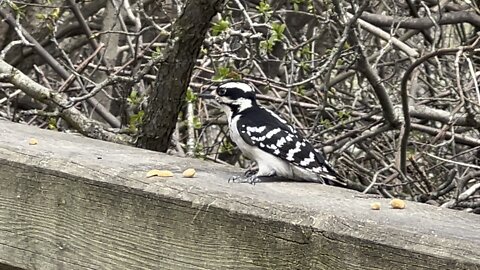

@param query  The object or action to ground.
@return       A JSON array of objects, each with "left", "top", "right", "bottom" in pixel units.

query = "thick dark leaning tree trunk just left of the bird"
[{"left": 137, "top": 0, "right": 224, "bottom": 152}]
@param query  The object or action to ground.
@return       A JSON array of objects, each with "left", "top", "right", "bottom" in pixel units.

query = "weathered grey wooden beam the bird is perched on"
[{"left": 0, "top": 121, "right": 480, "bottom": 269}]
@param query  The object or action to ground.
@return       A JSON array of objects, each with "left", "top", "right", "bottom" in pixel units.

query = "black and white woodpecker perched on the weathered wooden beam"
[{"left": 206, "top": 81, "right": 345, "bottom": 186}]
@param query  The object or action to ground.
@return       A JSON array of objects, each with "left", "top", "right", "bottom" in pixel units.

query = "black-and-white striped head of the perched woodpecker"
[{"left": 201, "top": 81, "right": 257, "bottom": 118}]
